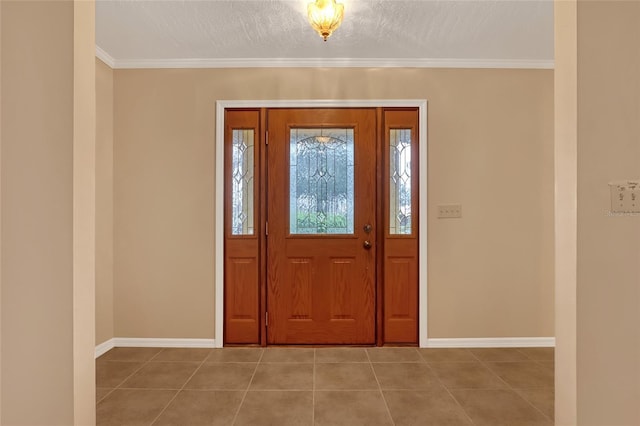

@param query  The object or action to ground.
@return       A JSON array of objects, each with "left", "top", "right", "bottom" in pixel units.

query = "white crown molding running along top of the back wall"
[{"left": 102, "top": 55, "right": 554, "bottom": 69}]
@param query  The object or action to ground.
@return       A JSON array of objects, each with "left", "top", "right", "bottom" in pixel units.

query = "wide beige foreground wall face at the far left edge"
[{"left": 1, "top": 2, "right": 73, "bottom": 425}]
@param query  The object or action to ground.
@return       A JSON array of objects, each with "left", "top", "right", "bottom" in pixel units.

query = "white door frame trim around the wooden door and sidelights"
[{"left": 214, "top": 99, "right": 428, "bottom": 348}]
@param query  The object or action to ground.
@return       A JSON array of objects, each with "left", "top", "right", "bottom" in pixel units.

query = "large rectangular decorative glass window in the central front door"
[{"left": 289, "top": 128, "right": 354, "bottom": 234}]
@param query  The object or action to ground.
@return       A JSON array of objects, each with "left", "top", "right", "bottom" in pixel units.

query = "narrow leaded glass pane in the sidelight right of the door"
[{"left": 389, "top": 129, "right": 411, "bottom": 235}]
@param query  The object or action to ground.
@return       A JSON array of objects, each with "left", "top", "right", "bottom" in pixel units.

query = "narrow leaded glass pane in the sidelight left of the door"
[{"left": 231, "top": 129, "right": 254, "bottom": 235}]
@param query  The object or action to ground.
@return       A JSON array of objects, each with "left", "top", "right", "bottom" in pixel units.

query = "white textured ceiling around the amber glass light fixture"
[{"left": 96, "top": 0, "right": 553, "bottom": 67}]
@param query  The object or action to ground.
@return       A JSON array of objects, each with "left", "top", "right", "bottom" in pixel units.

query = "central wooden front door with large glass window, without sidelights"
[{"left": 266, "top": 109, "right": 376, "bottom": 344}]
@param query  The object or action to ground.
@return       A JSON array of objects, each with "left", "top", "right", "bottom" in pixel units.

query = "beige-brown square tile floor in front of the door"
[{"left": 96, "top": 347, "right": 554, "bottom": 426}]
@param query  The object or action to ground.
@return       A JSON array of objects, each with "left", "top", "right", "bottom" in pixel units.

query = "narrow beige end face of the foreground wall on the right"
[{"left": 554, "top": 0, "right": 578, "bottom": 426}]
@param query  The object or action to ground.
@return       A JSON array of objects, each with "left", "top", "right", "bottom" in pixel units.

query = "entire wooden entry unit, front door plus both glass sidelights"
[{"left": 223, "top": 107, "right": 420, "bottom": 345}]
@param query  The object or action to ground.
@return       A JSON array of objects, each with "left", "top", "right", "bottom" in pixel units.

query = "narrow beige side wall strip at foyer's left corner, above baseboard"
[{"left": 95, "top": 59, "right": 114, "bottom": 345}]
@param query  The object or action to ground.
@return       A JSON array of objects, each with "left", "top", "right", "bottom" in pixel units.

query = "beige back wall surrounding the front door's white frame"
[{"left": 114, "top": 68, "right": 554, "bottom": 338}]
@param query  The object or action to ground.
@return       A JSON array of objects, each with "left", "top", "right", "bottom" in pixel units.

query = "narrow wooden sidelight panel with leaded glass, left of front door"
[{"left": 224, "top": 110, "right": 263, "bottom": 344}]
